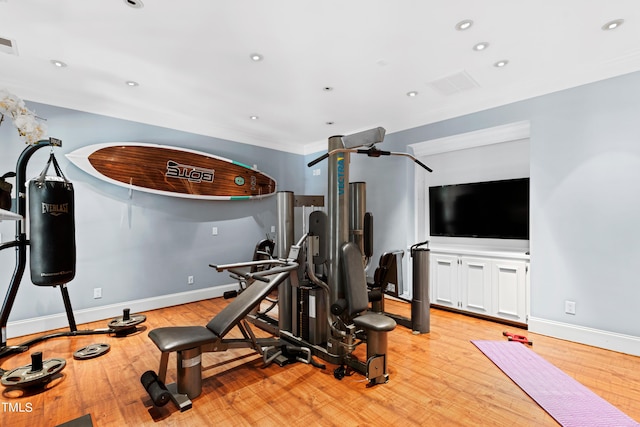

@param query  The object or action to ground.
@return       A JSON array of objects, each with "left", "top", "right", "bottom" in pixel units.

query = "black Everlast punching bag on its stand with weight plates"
[{"left": 0, "top": 138, "right": 146, "bottom": 388}]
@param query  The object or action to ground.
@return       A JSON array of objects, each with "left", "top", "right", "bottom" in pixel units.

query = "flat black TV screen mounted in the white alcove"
[{"left": 429, "top": 178, "right": 529, "bottom": 240}]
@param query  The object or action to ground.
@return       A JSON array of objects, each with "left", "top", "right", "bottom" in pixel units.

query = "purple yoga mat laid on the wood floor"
[{"left": 471, "top": 340, "right": 640, "bottom": 427}]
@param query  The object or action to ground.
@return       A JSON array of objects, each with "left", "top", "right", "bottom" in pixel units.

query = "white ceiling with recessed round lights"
[{"left": 0, "top": 0, "right": 640, "bottom": 153}]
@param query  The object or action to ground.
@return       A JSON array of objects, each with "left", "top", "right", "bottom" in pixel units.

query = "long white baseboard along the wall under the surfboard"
[{"left": 7, "top": 283, "right": 238, "bottom": 338}]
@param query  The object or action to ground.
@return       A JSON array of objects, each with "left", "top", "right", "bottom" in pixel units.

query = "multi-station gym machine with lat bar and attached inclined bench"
[{"left": 141, "top": 128, "right": 430, "bottom": 410}]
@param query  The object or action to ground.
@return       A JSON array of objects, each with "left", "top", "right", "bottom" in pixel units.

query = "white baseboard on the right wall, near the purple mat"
[{"left": 528, "top": 317, "right": 640, "bottom": 356}]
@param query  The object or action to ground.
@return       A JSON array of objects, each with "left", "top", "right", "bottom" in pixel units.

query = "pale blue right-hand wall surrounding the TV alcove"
[{"left": 351, "top": 73, "right": 640, "bottom": 344}]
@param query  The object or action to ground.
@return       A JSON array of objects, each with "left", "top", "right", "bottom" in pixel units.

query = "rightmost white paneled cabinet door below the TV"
[{"left": 492, "top": 260, "right": 527, "bottom": 323}]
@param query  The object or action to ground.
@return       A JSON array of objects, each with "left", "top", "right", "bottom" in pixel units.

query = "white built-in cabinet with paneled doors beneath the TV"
[{"left": 429, "top": 247, "right": 529, "bottom": 325}]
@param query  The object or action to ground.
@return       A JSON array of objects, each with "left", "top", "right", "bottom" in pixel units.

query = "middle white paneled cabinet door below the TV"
[{"left": 460, "top": 256, "right": 492, "bottom": 315}]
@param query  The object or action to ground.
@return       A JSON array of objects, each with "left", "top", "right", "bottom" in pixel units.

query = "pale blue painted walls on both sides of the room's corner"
[{"left": 0, "top": 73, "right": 640, "bottom": 352}]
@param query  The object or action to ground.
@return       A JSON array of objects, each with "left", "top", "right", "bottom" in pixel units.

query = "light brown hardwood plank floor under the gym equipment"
[{"left": 0, "top": 299, "right": 640, "bottom": 427}]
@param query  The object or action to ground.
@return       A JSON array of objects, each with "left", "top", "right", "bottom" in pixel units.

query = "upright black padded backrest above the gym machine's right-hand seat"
[{"left": 340, "top": 242, "right": 369, "bottom": 316}]
